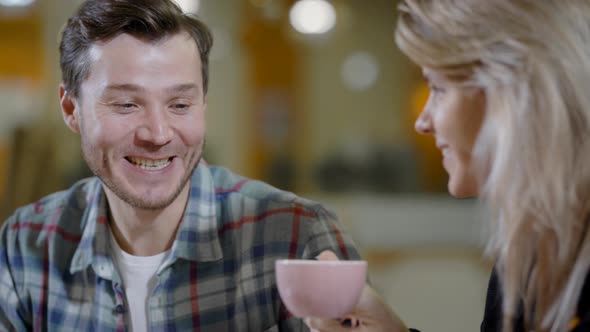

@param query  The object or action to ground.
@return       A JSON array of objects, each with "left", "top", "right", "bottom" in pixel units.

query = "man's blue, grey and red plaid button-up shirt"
[{"left": 0, "top": 163, "right": 359, "bottom": 331}]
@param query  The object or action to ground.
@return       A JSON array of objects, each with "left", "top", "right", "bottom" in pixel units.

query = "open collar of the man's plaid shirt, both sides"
[{"left": 70, "top": 161, "right": 223, "bottom": 279}]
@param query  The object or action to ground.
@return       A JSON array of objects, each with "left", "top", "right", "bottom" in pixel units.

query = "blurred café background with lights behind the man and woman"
[{"left": 0, "top": 0, "right": 491, "bottom": 331}]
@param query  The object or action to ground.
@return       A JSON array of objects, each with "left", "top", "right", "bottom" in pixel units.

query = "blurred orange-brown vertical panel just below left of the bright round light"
[{"left": 241, "top": 1, "right": 305, "bottom": 190}]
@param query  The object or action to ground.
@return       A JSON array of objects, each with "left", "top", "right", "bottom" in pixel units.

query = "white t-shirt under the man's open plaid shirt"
[{"left": 111, "top": 232, "right": 169, "bottom": 332}]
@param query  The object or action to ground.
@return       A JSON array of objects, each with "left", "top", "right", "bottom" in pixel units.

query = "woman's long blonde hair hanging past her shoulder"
[{"left": 396, "top": 0, "right": 590, "bottom": 331}]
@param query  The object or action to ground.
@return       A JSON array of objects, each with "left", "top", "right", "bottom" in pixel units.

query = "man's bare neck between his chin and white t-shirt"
[{"left": 105, "top": 183, "right": 190, "bottom": 256}]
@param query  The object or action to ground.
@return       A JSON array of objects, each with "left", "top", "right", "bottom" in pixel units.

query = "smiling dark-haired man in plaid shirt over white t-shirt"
[{"left": 0, "top": 0, "right": 358, "bottom": 331}]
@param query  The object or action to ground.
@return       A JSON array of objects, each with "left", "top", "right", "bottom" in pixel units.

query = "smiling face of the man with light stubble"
[{"left": 62, "top": 33, "right": 207, "bottom": 209}]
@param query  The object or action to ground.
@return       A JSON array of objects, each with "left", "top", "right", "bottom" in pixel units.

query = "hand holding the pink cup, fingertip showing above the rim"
[{"left": 305, "top": 251, "right": 408, "bottom": 332}]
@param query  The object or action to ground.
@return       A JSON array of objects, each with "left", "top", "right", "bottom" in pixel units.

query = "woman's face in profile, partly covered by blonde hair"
[{"left": 415, "top": 69, "right": 486, "bottom": 198}]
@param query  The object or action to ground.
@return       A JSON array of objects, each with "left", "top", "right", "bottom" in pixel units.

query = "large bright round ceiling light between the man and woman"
[{"left": 289, "top": 0, "right": 336, "bottom": 34}]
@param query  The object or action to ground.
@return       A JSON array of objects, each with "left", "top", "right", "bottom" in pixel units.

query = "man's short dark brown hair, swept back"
[{"left": 59, "top": 0, "right": 213, "bottom": 96}]
